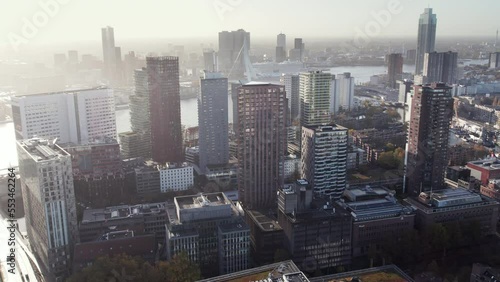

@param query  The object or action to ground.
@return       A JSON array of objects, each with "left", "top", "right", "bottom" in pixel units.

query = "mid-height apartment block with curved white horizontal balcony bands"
[{"left": 301, "top": 124, "right": 348, "bottom": 199}]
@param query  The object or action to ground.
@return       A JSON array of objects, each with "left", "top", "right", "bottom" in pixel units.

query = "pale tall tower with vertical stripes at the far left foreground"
[{"left": 17, "top": 138, "right": 79, "bottom": 281}]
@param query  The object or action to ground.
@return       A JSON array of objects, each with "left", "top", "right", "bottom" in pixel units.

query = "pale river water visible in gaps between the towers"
[{"left": 0, "top": 60, "right": 487, "bottom": 167}]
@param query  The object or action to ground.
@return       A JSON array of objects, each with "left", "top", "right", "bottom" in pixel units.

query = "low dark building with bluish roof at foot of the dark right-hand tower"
[{"left": 405, "top": 188, "right": 500, "bottom": 235}]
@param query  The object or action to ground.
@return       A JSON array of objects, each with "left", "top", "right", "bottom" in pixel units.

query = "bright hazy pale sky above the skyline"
[{"left": 0, "top": 0, "right": 500, "bottom": 47}]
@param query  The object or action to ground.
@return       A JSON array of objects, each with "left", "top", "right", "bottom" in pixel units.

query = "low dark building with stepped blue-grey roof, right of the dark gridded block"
[{"left": 337, "top": 186, "right": 415, "bottom": 257}]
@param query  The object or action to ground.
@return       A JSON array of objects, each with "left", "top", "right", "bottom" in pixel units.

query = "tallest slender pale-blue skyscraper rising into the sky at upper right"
[{"left": 415, "top": 8, "right": 437, "bottom": 74}]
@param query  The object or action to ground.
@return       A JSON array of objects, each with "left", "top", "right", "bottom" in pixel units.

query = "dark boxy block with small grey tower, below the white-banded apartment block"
[{"left": 278, "top": 180, "right": 352, "bottom": 273}]
